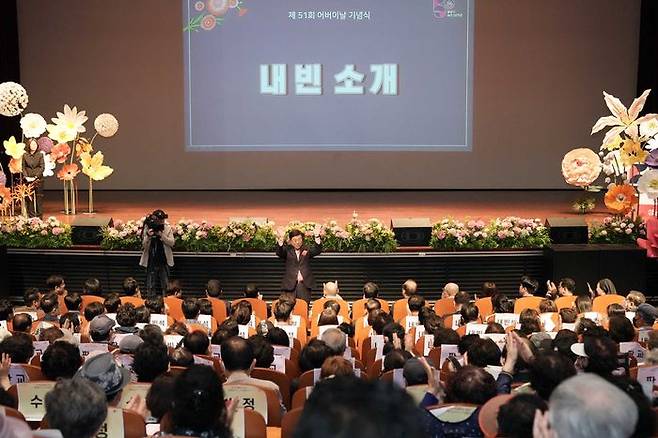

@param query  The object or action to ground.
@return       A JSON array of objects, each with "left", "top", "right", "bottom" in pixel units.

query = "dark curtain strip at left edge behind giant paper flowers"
[{"left": 0, "top": 0, "right": 21, "bottom": 185}]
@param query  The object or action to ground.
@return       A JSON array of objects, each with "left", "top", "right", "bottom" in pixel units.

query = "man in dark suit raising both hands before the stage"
[{"left": 276, "top": 230, "right": 322, "bottom": 302}]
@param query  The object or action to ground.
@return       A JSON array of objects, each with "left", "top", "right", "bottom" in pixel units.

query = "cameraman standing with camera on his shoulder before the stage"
[{"left": 139, "top": 210, "right": 175, "bottom": 297}]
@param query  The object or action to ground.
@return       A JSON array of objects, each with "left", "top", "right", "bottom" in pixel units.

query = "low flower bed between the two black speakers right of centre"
[{"left": 430, "top": 216, "right": 550, "bottom": 251}]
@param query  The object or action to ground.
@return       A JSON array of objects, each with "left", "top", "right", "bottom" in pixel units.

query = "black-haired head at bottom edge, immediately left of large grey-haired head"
[{"left": 498, "top": 394, "right": 548, "bottom": 438}]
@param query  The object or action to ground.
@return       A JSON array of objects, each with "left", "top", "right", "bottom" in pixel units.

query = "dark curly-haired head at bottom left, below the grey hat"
[{"left": 44, "top": 379, "right": 107, "bottom": 438}]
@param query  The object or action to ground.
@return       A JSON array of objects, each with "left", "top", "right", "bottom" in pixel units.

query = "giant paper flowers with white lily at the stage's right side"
[{"left": 562, "top": 90, "right": 658, "bottom": 216}]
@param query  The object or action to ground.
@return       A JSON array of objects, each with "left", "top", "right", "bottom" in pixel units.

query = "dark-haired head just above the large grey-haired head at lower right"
[{"left": 530, "top": 350, "right": 576, "bottom": 400}]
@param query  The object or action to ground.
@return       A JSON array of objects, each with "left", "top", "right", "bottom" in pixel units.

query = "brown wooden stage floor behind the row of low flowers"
[{"left": 37, "top": 190, "right": 607, "bottom": 225}]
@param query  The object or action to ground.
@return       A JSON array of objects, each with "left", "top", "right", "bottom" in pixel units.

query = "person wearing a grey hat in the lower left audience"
[{"left": 74, "top": 353, "right": 130, "bottom": 406}]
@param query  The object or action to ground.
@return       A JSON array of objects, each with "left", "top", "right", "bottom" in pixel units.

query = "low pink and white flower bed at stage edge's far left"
[{"left": 0, "top": 216, "right": 72, "bottom": 248}]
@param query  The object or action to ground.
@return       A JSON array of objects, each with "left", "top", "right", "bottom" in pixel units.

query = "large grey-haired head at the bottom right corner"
[{"left": 533, "top": 373, "right": 638, "bottom": 438}]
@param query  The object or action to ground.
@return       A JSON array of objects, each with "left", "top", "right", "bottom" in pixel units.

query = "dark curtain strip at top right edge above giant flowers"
[{"left": 637, "top": 0, "right": 658, "bottom": 114}]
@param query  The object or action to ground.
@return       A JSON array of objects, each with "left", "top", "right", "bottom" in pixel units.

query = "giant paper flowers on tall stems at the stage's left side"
[{"left": 0, "top": 82, "right": 119, "bottom": 216}]
